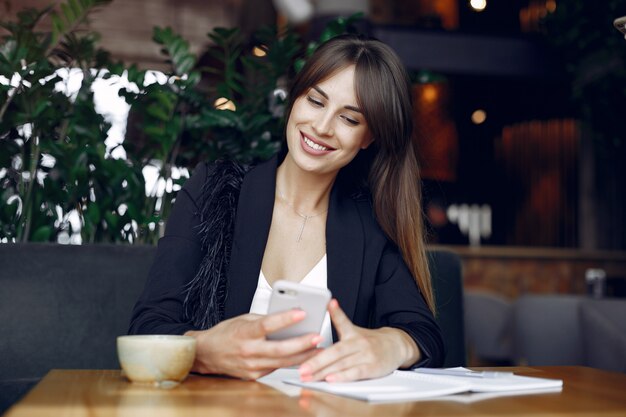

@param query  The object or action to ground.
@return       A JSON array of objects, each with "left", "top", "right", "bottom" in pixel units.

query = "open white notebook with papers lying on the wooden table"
[{"left": 283, "top": 368, "right": 563, "bottom": 402}]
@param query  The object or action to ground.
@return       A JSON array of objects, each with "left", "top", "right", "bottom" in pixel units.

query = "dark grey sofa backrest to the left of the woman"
[{"left": 0, "top": 244, "right": 156, "bottom": 412}]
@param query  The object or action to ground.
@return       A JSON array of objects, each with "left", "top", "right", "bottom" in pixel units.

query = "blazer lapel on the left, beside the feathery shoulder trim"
[{"left": 224, "top": 157, "right": 277, "bottom": 319}]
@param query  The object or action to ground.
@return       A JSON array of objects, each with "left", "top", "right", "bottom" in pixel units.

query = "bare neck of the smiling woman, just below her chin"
[{"left": 276, "top": 156, "right": 336, "bottom": 215}]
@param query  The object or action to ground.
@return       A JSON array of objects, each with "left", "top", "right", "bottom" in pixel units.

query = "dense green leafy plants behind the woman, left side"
[{"left": 0, "top": 0, "right": 359, "bottom": 243}]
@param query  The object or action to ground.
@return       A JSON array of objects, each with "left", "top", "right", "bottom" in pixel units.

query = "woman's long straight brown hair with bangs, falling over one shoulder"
[{"left": 287, "top": 35, "right": 435, "bottom": 312}]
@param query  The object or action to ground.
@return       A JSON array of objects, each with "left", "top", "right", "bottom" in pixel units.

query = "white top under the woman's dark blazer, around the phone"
[{"left": 250, "top": 254, "right": 333, "bottom": 347}]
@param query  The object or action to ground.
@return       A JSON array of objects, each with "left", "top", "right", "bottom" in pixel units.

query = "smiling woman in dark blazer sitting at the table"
[{"left": 130, "top": 35, "right": 444, "bottom": 381}]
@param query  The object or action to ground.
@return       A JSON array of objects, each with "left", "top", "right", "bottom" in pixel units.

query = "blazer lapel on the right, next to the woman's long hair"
[{"left": 326, "top": 186, "right": 365, "bottom": 340}]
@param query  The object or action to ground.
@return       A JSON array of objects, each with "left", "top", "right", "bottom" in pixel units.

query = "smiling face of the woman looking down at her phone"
[{"left": 287, "top": 65, "right": 372, "bottom": 175}]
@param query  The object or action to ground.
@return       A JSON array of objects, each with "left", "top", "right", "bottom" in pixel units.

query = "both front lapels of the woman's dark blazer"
[{"left": 224, "top": 157, "right": 365, "bottom": 332}]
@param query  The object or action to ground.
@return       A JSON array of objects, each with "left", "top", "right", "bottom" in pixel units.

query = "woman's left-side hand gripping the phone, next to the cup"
[{"left": 185, "top": 310, "right": 322, "bottom": 379}]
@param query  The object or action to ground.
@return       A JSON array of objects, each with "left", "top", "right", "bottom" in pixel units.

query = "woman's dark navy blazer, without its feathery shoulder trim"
[{"left": 129, "top": 157, "right": 445, "bottom": 367}]
